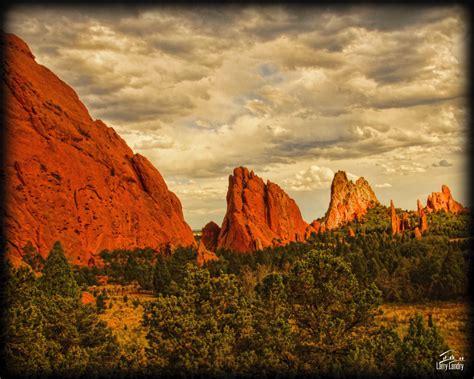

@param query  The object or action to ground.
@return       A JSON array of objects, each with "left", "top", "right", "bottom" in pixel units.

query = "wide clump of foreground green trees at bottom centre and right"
[{"left": 144, "top": 250, "right": 448, "bottom": 376}]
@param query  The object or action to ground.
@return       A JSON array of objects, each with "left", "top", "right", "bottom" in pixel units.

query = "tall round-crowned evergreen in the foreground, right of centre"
[{"left": 286, "top": 250, "right": 381, "bottom": 373}]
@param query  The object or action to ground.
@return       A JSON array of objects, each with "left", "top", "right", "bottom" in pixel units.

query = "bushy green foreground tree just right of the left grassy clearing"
[{"left": 144, "top": 264, "right": 252, "bottom": 374}]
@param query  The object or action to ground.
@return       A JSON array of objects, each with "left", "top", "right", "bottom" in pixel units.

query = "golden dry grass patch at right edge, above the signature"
[{"left": 377, "top": 302, "right": 470, "bottom": 357}]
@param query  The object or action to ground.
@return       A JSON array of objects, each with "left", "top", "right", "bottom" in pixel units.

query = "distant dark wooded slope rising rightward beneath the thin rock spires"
[{"left": 207, "top": 206, "right": 471, "bottom": 302}]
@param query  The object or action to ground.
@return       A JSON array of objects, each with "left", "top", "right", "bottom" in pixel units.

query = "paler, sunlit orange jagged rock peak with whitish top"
[{"left": 324, "top": 171, "right": 379, "bottom": 229}]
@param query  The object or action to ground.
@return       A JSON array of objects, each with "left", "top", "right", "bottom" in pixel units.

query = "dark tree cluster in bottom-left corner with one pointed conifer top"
[{"left": 2, "top": 243, "right": 118, "bottom": 377}]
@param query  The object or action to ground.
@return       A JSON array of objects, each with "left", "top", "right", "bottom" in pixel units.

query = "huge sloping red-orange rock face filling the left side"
[{"left": 2, "top": 35, "right": 195, "bottom": 265}]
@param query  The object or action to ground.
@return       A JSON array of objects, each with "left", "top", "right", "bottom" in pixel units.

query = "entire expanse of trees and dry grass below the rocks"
[{"left": 5, "top": 207, "right": 471, "bottom": 376}]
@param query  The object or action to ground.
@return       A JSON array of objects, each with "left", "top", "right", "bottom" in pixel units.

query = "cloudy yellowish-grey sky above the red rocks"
[{"left": 6, "top": 5, "right": 469, "bottom": 229}]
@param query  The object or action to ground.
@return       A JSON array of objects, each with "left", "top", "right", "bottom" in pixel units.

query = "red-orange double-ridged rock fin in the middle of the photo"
[{"left": 218, "top": 167, "right": 308, "bottom": 252}]
